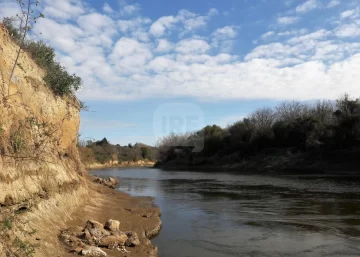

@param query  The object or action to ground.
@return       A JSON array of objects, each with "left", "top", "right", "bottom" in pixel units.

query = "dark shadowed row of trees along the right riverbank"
[{"left": 157, "top": 95, "right": 360, "bottom": 168}]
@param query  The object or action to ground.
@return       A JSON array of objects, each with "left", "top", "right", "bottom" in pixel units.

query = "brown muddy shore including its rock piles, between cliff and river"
[{"left": 59, "top": 176, "right": 161, "bottom": 257}]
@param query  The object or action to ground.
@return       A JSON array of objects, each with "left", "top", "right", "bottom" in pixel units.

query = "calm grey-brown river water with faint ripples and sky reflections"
[{"left": 90, "top": 169, "right": 360, "bottom": 257}]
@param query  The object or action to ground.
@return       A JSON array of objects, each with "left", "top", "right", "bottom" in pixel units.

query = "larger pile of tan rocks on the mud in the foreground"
[{"left": 59, "top": 219, "right": 140, "bottom": 254}]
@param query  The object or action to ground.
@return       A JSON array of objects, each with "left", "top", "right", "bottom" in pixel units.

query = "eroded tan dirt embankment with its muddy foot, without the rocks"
[{"left": 0, "top": 24, "right": 160, "bottom": 257}]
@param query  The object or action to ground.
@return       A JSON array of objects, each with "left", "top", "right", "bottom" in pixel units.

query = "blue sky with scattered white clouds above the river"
[{"left": 0, "top": 0, "right": 360, "bottom": 145}]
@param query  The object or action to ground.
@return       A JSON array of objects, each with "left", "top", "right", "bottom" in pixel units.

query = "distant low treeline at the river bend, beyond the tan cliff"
[{"left": 78, "top": 138, "right": 157, "bottom": 164}]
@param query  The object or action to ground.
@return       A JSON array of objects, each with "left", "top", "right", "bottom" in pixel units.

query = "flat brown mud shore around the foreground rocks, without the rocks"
[{"left": 66, "top": 177, "right": 161, "bottom": 257}]
